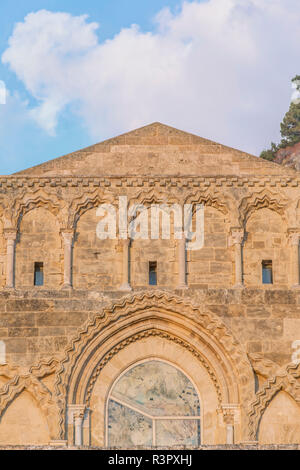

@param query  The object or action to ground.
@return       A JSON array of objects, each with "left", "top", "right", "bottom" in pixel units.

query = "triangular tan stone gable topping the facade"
[{"left": 13, "top": 122, "right": 295, "bottom": 177}]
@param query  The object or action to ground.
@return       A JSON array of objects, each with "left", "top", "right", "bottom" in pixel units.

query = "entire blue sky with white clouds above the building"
[{"left": 0, "top": 0, "right": 300, "bottom": 175}]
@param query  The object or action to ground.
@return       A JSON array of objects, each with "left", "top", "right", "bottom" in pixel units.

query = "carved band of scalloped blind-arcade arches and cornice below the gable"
[{"left": 0, "top": 184, "right": 300, "bottom": 231}]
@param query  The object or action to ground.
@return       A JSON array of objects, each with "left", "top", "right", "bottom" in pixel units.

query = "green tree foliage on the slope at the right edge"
[{"left": 260, "top": 75, "right": 300, "bottom": 161}]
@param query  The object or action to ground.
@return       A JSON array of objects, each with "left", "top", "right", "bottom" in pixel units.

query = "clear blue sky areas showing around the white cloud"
[{"left": 0, "top": 0, "right": 184, "bottom": 174}]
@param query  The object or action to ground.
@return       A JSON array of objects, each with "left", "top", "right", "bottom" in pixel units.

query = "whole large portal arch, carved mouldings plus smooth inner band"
[{"left": 56, "top": 291, "right": 254, "bottom": 445}]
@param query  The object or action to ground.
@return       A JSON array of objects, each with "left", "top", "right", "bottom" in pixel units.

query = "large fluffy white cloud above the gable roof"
[{"left": 2, "top": 0, "right": 300, "bottom": 153}]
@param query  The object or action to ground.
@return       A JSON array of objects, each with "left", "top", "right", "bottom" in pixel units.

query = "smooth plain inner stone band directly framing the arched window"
[{"left": 89, "top": 336, "right": 220, "bottom": 447}]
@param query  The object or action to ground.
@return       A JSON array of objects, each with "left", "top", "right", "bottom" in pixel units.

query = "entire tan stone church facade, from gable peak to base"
[{"left": 0, "top": 123, "right": 300, "bottom": 448}]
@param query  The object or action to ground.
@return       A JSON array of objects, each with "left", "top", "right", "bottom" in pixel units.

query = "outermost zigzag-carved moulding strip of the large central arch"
[{"left": 55, "top": 291, "right": 253, "bottom": 439}]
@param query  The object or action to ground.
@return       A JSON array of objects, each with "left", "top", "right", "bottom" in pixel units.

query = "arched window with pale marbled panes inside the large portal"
[{"left": 107, "top": 360, "right": 200, "bottom": 448}]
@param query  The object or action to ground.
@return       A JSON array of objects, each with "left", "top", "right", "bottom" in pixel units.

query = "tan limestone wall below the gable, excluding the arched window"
[{"left": 0, "top": 169, "right": 300, "bottom": 446}]
